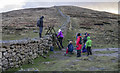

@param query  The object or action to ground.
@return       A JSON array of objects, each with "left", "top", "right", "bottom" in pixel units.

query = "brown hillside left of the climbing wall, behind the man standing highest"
[{"left": 2, "top": 7, "right": 64, "bottom": 40}]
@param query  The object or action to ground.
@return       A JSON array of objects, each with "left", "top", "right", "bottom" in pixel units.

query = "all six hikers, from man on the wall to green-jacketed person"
[{"left": 37, "top": 16, "right": 92, "bottom": 57}]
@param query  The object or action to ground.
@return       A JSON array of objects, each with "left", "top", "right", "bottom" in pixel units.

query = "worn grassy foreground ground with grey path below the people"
[{"left": 16, "top": 48, "right": 118, "bottom": 71}]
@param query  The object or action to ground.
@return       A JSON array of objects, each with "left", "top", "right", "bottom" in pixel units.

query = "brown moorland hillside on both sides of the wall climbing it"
[{"left": 2, "top": 6, "right": 118, "bottom": 47}]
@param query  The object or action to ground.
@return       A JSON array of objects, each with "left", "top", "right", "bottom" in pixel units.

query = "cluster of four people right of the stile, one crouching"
[{"left": 65, "top": 32, "right": 92, "bottom": 57}]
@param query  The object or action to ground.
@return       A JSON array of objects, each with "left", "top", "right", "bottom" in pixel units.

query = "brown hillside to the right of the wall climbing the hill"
[{"left": 59, "top": 6, "right": 119, "bottom": 48}]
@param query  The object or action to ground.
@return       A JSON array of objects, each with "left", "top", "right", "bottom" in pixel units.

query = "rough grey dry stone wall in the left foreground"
[{"left": 0, "top": 35, "right": 52, "bottom": 70}]
